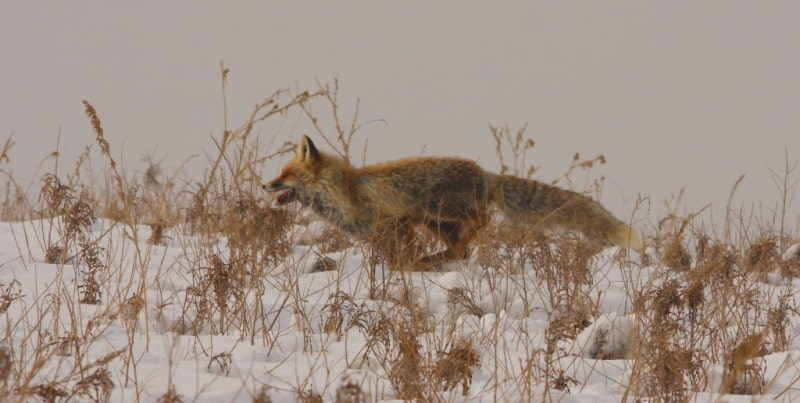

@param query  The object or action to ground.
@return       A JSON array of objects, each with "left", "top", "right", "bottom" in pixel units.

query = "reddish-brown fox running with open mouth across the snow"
[{"left": 262, "top": 135, "right": 642, "bottom": 271}]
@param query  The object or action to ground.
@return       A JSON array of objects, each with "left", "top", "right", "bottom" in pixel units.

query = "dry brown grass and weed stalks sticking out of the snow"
[{"left": 0, "top": 76, "right": 800, "bottom": 402}]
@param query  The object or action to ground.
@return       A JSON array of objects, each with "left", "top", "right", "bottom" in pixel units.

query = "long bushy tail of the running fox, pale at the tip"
[{"left": 486, "top": 173, "right": 642, "bottom": 250}]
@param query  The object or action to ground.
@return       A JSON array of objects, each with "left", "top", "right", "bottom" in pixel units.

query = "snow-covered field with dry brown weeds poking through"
[{"left": 0, "top": 213, "right": 800, "bottom": 403}]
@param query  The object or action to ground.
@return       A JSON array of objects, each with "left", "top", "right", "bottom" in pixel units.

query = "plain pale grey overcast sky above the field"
[{"left": 0, "top": 0, "right": 800, "bottom": 235}]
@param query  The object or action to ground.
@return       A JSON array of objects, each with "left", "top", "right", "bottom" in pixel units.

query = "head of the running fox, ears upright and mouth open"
[{"left": 262, "top": 135, "right": 320, "bottom": 205}]
